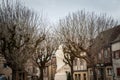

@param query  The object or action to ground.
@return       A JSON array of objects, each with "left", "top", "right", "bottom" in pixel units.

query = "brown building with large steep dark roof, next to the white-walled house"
[{"left": 88, "top": 26, "right": 120, "bottom": 80}]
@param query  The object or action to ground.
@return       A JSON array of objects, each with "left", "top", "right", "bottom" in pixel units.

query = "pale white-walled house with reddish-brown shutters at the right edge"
[{"left": 111, "top": 34, "right": 120, "bottom": 80}]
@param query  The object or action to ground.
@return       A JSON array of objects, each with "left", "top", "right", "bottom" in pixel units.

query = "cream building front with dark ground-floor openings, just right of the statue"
[{"left": 73, "top": 58, "right": 88, "bottom": 80}]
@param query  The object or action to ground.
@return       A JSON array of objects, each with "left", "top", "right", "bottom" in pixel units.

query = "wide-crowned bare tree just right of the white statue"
[{"left": 56, "top": 10, "right": 117, "bottom": 80}]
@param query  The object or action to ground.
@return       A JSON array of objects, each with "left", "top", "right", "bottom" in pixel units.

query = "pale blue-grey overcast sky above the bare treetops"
[{"left": 12, "top": 0, "right": 120, "bottom": 22}]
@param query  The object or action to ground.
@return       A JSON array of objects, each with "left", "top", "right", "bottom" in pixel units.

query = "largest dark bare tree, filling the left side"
[{"left": 0, "top": 0, "right": 45, "bottom": 80}]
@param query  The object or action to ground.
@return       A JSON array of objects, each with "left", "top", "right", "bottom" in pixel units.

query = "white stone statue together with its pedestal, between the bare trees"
[{"left": 55, "top": 45, "right": 70, "bottom": 80}]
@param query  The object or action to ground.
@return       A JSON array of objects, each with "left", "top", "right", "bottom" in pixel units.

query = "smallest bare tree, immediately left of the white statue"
[{"left": 33, "top": 33, "right": 57, "bottom": 80}]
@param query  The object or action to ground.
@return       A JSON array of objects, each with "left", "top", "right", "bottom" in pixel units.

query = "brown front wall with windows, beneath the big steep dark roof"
[{"left": 95, "top": 46, "right": 113, "bottom": 80}]
